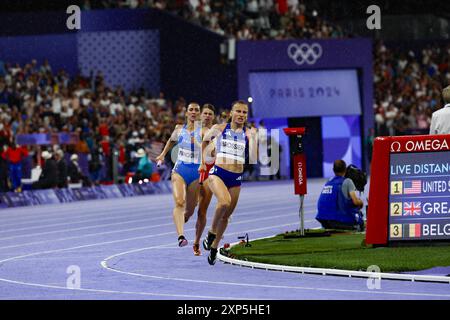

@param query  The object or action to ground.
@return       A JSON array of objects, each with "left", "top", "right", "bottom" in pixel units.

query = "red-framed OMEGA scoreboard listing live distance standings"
[{"left": 366, "top": 135, "right": 450, "bottom": 244}]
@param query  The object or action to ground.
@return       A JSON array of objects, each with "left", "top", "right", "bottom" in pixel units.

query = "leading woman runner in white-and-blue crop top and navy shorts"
[{"left": 199, "top": 101, "right": 257, "bottom": 265}]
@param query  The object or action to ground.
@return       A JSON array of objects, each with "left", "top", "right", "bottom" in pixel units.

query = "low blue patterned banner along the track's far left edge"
[{"left": 0, "top": 181, "right": 172, "bottom": 209}]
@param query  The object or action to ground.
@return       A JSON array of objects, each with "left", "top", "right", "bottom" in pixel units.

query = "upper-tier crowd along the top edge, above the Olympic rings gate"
[{"left": 83, "top": 0, "right": 345, "bottom": 40}]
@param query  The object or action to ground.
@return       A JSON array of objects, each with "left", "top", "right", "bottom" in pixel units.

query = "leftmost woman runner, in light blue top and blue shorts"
[{"left": 156, "top": 103, "right": 202, "bottom": 247}]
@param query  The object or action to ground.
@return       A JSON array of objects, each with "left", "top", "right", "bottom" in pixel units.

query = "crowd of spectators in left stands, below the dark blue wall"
[{"left": 0, "top": 60, "right": 220, "bottom": 190}]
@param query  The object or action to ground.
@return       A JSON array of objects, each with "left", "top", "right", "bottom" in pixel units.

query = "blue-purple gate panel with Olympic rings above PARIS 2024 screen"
[{"left": 236, "top": 38, "right": 375, "bottom": 170}]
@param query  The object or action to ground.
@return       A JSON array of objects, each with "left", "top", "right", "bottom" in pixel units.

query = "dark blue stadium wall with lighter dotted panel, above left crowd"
[{"left": 0, "top": 9, "right": 237, "bottom": 106}]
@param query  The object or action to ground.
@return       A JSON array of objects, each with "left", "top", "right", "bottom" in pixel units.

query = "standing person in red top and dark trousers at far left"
[{"left": 2, "top": 142, "right": 28, "bottom": 192}]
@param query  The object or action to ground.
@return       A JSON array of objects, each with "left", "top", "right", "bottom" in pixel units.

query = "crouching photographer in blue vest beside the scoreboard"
[{"left": 316, "top": 160, "right": 367, "bottom": 231}]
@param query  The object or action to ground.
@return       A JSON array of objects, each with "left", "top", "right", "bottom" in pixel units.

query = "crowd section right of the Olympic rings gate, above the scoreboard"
[{"left": 374, "top": 42, "right": 450, "bottom": 136}]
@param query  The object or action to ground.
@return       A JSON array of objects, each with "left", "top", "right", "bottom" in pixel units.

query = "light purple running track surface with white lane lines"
[{"left": 0, "top": 180, "right": 450, "bottom": 300}]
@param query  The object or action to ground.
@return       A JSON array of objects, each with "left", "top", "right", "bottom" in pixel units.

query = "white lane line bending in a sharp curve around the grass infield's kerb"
[{"left": 100, "top": 226, "right": 450, "bottom": 297}]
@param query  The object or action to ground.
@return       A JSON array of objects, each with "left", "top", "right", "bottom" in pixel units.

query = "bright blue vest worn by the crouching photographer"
[{"left": 316, "top": 176, "right": 362, "bottom": 225}]
